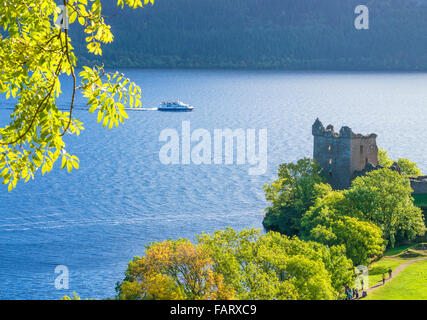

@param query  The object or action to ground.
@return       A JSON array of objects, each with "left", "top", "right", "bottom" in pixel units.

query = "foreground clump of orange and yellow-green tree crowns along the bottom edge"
[{"left": 117, "top": 229, "right": 354, "bottom": 300}]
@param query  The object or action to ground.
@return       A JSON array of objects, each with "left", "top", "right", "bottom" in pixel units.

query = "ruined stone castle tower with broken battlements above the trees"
[{"left": 312, "top": 119, "right": 378, "bottom": 189}]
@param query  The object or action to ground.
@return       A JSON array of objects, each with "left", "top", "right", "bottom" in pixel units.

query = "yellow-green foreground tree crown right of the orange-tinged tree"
[{"left": 199, "top": 229, "right": 353, "bottom": 300}]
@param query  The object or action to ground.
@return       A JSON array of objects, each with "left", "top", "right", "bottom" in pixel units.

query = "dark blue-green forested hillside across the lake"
[{"left": 71, "top": 0, "right": 427, "bottom": 70}]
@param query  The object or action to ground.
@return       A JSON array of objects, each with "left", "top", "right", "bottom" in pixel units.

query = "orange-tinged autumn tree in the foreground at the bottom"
[{"left": 117, "top": 239, "right": 234, "bottom": 300}]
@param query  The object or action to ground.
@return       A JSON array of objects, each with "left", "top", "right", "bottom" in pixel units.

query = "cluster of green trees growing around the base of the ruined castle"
[{"left": 264, "top": 159, "right": 426, "bottom": 264}]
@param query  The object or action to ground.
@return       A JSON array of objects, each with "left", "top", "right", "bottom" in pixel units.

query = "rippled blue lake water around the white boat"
[{"left": 0, "top": 70, "right": 427, "bottom": 299}]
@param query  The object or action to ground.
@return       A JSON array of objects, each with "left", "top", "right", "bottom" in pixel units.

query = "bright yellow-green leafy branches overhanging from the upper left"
[{"left": 0, "top": 0, "right": 154, "bottom": 191}]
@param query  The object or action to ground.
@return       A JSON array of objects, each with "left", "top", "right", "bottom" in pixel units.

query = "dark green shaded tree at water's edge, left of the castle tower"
[{"left": 263, "top": 158, "right": 330, "bottom": 236}]
